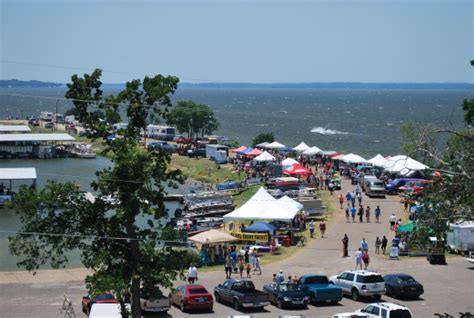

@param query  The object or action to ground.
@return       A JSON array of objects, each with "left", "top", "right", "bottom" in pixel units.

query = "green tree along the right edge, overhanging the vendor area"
[{"left": 408, "top": 61, "right": 474, "bottom": 250}]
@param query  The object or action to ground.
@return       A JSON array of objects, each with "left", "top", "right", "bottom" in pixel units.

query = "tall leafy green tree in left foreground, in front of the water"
[{"left": 10, "top": 69, "right": 191, "bottom": 318}]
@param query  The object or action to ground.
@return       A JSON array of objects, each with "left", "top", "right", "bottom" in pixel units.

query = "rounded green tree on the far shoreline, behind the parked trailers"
[{"left": 168, "top": 101, "right": 219, "bottom": 138}]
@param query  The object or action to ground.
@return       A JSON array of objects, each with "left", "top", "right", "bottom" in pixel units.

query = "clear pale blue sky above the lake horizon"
[{"left": 0, "top": 0, "right": 474, "bottom": 83}]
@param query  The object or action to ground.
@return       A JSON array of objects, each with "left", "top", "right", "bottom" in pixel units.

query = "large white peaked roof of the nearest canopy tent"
[{"left": 224, "top": 187, "right": 300, "bottom": 222}]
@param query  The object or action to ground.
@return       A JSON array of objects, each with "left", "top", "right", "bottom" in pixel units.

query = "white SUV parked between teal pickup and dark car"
[{"left": 329, "top": 270, "right": 385, "bottom": 300}]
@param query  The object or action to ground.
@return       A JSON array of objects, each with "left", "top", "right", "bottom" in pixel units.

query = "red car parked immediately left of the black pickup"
[{"left": 169, "top": 285, "right": 214, "bottom": 312}]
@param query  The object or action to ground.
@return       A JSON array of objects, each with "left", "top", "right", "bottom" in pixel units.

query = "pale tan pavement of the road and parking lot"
[{"left": 0, "top": 178, "right": 474, "bottom": 318}]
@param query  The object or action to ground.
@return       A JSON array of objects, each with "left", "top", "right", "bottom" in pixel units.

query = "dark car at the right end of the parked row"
[{"left": 383, "top": 274, "right": 424, "bottom": 298}]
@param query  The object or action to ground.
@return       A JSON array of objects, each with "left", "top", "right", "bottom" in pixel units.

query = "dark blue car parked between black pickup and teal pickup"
[{"left": 263, "top": 283, "right": 309, "bottom": 308}]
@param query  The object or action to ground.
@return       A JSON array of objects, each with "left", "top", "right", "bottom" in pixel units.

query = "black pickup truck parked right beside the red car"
[{"left": 214, "top": 279, "right": 270, "bottom": 310}]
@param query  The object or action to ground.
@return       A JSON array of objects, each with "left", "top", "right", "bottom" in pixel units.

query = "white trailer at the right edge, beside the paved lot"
[{"left": 447, "top": 221, "right": 474, "bottom": 254}]
